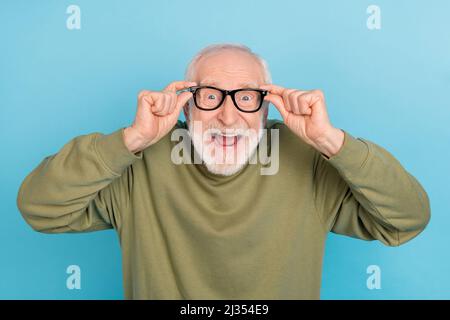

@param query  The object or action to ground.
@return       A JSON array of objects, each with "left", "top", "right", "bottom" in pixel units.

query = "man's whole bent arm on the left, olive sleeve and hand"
[{"left": 17, "top": 81, "right": 196, "bottom": 233}]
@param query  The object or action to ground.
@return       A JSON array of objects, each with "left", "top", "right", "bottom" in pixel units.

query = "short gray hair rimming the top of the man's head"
[{"left": 184, "top": 43, "right": 272, "bottom": 84}]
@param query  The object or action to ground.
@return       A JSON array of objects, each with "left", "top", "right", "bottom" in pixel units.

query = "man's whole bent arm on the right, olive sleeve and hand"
[{"left": 260, "top": 84, "right": 430, "bottom": 246}]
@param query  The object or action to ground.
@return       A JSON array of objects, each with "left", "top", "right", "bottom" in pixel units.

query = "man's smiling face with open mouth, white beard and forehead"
[{"left": 184, "top": 50, "right": 267, "bottom": 175}]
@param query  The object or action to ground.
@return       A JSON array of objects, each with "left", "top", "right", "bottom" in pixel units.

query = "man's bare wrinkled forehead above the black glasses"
[{"left": 196, "top": 50, "right": 264, "bottom": 87}]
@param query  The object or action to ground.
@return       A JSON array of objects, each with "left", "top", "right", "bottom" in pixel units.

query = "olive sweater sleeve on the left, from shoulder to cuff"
[{"left": 17, "top": 128, "right": 142, "bottom": 233}]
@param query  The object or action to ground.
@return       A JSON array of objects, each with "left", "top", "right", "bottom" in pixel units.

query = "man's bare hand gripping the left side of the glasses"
[{"left": 124, "top": 81, "right": 196, "bottom": 153}]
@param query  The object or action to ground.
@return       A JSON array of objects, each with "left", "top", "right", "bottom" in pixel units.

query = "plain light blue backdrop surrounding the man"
[{"left": 0, "top": 0, "right": 450, "bottom": 299}]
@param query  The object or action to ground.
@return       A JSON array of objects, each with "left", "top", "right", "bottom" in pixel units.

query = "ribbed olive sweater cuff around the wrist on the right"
[{"left": 325, "top": 130, "right": 370, "bottom": 174}]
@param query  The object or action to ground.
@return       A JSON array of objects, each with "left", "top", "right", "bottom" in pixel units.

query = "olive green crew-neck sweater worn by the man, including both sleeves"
[{"left": 17, "top": 120, "right": 430, "bottom": 299}]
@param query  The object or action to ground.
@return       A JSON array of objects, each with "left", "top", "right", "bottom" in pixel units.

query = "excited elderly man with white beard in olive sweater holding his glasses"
[{"left": 17, "top": 44, "right": 430, "bottom": 299}]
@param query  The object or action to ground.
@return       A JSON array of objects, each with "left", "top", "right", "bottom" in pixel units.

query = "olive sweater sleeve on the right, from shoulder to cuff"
[{"left": 314, "top": 131, "right": 430, "bottom": 246}]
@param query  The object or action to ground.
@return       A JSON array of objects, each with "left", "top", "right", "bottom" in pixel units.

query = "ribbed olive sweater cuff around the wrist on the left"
[{"left": 95, "top": 128, "right": 142, "bottom": 176}]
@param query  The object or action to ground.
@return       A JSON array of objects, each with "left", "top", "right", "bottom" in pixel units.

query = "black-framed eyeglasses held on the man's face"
[{"left": 186, "top": 86, "right": 268, "bottom": 113}]
